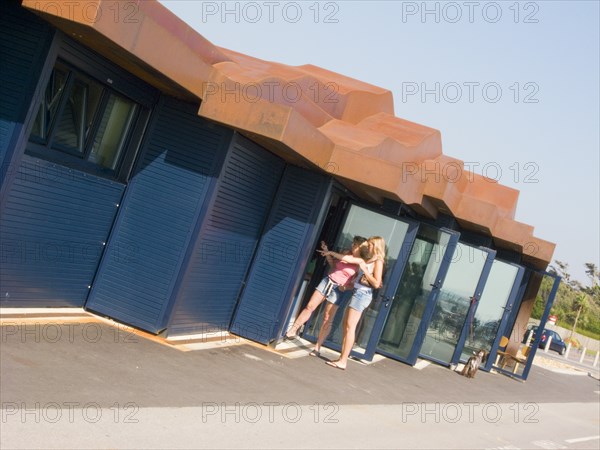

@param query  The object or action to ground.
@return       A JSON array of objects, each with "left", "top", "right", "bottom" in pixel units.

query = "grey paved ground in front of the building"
[{"left": 0, "top": 315, "right": 600, "bottom": 448}]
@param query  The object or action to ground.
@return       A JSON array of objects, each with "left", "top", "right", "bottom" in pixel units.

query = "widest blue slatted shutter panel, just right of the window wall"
[{"left": 86, "top": 98, "right": 231, "bottom": 332}]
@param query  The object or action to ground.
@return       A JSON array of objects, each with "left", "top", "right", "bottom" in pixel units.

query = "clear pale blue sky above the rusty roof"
[{"left": 160, "top": 0, "right": 600, "bottom": 284}]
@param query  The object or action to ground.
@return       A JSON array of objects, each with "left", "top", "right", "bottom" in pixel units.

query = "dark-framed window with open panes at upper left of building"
[{"left": 28, "top": 62, "right": 142, "bottom": 178}]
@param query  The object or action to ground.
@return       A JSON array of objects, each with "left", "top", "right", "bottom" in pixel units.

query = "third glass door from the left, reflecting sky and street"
[{"left": 420, "top": 242, "right": 496, "bottom": 365}]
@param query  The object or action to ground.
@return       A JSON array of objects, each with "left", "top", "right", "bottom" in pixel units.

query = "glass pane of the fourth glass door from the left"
[{"left": 460, "top": 260, "right": 519, "bottom": 362}]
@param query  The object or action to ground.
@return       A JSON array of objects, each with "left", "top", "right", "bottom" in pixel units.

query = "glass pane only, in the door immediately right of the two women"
[{"left": 378, "top": 226, "right": 450, "bottom": 358}]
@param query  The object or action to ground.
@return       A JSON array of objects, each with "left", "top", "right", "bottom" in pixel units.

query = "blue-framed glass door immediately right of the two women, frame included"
[{"left": 377, "top": 225, "right": 459, "bottom": 365}]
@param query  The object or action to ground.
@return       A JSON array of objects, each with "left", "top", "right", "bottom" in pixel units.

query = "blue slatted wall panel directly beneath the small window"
[{"left": 0, "top": 155, "right": 125, "bottom": 307}]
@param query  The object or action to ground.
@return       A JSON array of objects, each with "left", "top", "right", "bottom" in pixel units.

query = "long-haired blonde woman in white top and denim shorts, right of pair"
[{"left": 322, "top": 236, "right": 385, "bottom": 370}]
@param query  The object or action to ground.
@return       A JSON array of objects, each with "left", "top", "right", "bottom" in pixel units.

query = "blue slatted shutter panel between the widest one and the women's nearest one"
[{"left": 168, "top": 135, "right": 284, "bottom": 335}]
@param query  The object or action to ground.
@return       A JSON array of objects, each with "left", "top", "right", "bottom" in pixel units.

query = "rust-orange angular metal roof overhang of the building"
[{"left": 22, "top": 0, "right": 555, "bottom": 269}]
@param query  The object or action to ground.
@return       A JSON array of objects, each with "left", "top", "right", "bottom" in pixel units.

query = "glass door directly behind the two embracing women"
[{"left": 302, "top": 204, "right": 417, "bottom": 359}]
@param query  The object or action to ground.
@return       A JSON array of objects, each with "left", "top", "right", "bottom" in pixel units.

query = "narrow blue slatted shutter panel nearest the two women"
[{"left": 231, "top": 166, "right": 331, "bottom": 344}]
